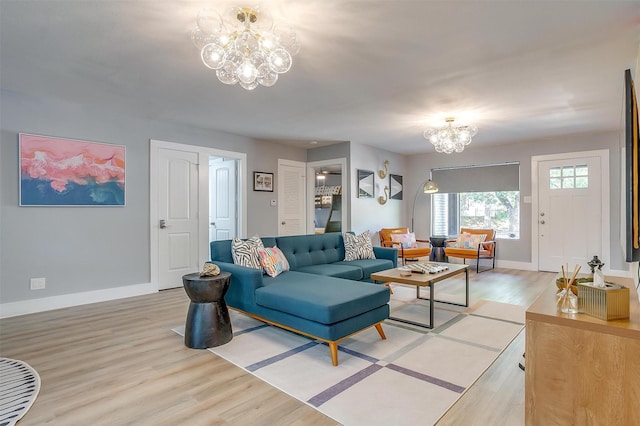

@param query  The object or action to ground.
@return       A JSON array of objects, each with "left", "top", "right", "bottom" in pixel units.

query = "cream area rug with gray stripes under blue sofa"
[{"left": 173, "top": 286, "right": 525, "bottom": 425}]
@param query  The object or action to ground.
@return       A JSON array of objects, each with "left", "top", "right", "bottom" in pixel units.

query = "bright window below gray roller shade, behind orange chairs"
[{"left": 431, "top": 191, "right": 520, "bottom": 239}]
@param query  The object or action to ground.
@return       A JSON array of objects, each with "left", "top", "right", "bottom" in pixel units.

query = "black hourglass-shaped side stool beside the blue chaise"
[{"left": 182, "top": 272, "right": 233, "bottom": 349}]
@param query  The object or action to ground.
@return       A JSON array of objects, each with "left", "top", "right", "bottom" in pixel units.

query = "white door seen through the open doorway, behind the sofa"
[{"left": 209, "top": 157, "right": 238, "bottom": 241}]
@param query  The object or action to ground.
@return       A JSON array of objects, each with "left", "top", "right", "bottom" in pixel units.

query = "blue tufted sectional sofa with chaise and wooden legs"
[{"left": 211, "top": 232, "right": 398, "bottom": 365}]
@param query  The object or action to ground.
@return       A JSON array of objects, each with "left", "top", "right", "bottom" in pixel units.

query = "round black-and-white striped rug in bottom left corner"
[{"left": 0, "top": 358, "right": 40, "bottom": 426}]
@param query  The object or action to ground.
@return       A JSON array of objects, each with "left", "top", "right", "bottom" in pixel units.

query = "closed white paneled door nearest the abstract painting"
[{"left": 157, "top": 148, "right": 200, "bottom": 290}]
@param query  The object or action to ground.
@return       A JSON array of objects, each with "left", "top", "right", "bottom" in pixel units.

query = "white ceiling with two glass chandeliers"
[{"left": 0, "top": 0, "right": 640, "bottom": 154}]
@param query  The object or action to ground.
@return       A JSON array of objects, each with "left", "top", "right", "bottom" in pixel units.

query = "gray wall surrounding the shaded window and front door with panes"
[{"left": 407, "top": 132, "right": 628, "bottom": 270}]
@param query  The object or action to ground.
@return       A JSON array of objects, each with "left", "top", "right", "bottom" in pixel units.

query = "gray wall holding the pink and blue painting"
[{"left": 0, "top": 91, "right": 306, "bottom": 303}]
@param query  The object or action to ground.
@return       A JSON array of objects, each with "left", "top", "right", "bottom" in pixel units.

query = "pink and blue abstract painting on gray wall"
[{"left": 20, "top": 133, "right": 125, "bottom": 206}]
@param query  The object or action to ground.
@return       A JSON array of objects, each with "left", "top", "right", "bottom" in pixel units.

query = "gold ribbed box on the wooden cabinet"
[{"left": 578, "top": 283, "right": 629, "bottom": 321}]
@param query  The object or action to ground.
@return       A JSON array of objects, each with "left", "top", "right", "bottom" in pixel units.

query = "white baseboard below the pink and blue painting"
[{"left": 0, "top": 283, "right": 158, "bottom": 318}]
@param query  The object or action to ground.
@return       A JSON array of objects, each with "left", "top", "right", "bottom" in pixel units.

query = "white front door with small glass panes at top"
[{"left": 533, "top": 156, "right": 609, "bottom": 274}]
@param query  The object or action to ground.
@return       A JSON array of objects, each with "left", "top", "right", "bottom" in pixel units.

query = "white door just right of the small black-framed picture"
[{"left": 278, "top": 160, "right": 307, "bottom": 235}]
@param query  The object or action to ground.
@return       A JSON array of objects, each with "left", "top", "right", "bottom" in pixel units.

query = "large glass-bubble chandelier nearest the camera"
[{"left": 191, "top": 7, "right": 300, "bottom": 90}]
